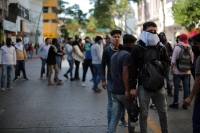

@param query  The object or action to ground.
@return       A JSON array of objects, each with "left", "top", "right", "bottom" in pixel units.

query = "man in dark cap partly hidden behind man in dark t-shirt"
[{"left": 101, "top": 30, "right": 128, "bottom": 131}]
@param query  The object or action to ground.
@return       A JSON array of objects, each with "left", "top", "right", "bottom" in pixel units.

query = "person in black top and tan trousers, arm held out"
[{"left": 47, "top": 38, "right": 64, "bottom": 85}]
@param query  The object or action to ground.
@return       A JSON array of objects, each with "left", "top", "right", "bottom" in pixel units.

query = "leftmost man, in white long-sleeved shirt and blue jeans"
[{"left": 0, "top": 38, "right": 16, "bottom": 91}]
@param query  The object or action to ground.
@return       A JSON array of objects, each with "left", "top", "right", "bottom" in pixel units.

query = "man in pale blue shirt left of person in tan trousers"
[{"left": 38, "top": 38, "right": 51, "bottom": 79}]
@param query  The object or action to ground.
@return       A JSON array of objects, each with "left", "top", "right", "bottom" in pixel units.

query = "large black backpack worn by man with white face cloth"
[{"left": 137, "top": 44, "right": 165, "bottom": 92}]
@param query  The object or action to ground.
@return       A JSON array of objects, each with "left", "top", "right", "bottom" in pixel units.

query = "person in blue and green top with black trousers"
[{"left": 82, "top": 36, "right": 94, "bottom": 86}]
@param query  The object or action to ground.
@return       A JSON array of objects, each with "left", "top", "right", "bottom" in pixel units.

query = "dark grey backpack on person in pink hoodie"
[{"left": 176, "top": 45, "right": 191, "bottom": 72}]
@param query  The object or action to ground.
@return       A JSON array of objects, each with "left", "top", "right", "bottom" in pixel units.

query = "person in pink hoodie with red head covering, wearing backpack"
[{"left": 169, "top": 34, "right": 194, "bottom": 109}]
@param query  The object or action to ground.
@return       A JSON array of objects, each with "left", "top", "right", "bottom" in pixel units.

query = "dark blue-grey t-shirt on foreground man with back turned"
[{"left": 110, "top": 50, "right": 131, "bottom": 95}]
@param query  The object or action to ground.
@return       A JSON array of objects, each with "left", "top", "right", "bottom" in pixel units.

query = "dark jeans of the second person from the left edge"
[{"left": 15, "top": 60, "right": 26, "bottom": 78}]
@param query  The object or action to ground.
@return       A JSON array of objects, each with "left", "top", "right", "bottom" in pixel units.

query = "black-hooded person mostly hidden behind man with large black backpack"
[{"left": 158, "top": 32, "right": 173, "bottom": 97}]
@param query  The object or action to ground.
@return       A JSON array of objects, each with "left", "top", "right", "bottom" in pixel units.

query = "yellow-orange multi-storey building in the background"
[{"left": 43, "top": 0, "right": 60, "bottom": 38}]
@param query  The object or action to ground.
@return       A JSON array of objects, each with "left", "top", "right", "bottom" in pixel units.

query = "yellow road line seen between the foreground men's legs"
[{"left": 125, "top": 115, "right": 162, "bottom": 133}]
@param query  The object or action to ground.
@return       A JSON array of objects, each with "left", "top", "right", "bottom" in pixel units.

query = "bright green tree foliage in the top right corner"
[{"left": 172, "top": 0, "right": 200, "bottom": 31}]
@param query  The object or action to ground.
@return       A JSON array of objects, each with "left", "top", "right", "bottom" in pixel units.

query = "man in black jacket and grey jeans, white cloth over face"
[{"left": 129, "top": 22, "right": 170, "bottom": 133}]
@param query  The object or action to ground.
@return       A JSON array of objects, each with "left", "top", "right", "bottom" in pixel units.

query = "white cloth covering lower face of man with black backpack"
[{"left": 140, "top": 31, "right": 160, "bottom": 46}]
